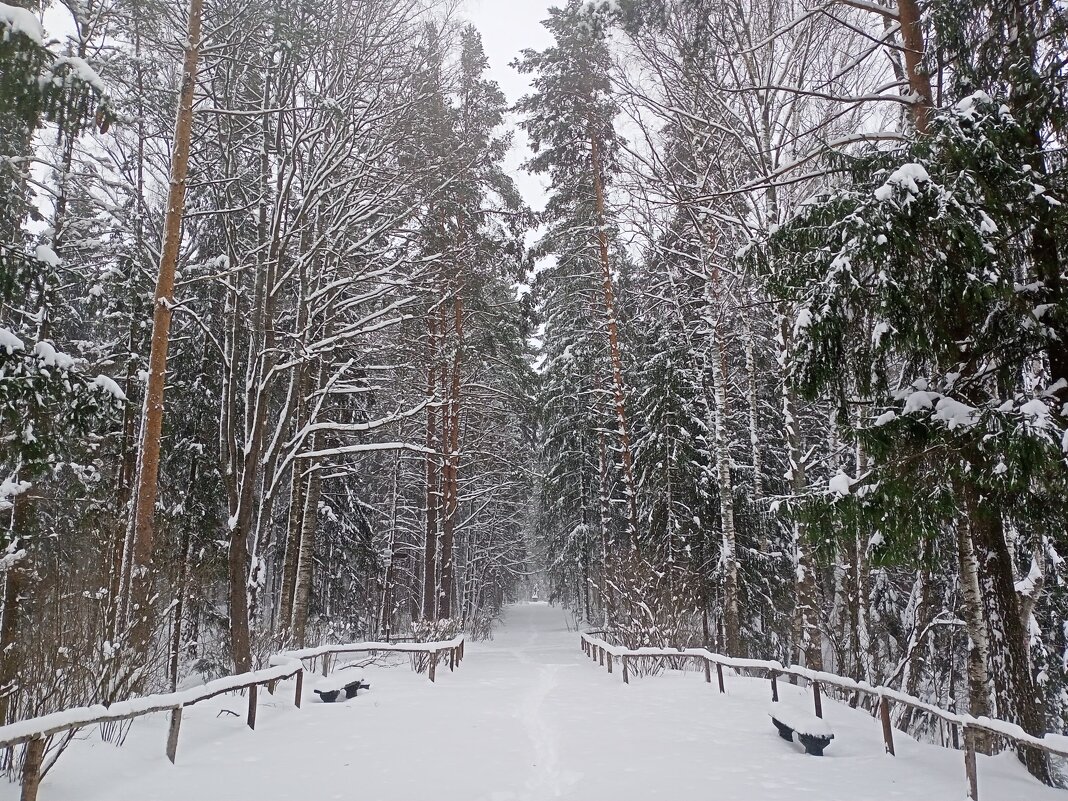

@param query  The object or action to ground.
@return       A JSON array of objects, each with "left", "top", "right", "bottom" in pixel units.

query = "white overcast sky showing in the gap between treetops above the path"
[{"left": 462, "top": 0, "right": 560, "bottom": 209}]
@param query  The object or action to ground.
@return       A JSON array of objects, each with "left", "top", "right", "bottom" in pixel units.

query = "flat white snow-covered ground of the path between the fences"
[{"left": 12, "top": 603, "right": 1068, "bottom": 801}]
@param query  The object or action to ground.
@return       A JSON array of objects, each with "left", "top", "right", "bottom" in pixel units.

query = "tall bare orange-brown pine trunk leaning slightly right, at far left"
[{"left": 129, "top": 0, "right": 204, "bottom": 654}]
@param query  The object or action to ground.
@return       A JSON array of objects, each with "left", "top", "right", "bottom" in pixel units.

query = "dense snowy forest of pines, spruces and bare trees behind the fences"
[{"left": 0, "top": 0, "right": 1068, "bottom": 783}]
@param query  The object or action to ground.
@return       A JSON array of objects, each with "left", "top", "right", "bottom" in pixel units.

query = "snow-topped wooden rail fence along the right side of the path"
[{"left": 582, "top": 631, "right": 1068, "bottom": 801}]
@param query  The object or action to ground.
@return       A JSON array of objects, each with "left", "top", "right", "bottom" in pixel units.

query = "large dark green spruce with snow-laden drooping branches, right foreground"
[{"left": 765, "top": 92, "right": 1068, "bottom": 780}]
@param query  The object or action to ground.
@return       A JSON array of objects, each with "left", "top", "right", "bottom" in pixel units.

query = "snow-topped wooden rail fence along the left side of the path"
[{"left": 0, "top": 634, "right": 465, "bottom": 801}]
